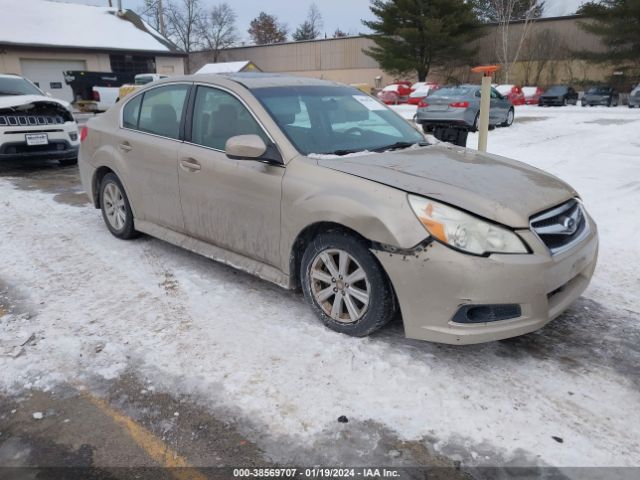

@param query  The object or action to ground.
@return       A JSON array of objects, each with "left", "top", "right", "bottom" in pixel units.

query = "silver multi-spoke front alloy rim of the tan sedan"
[{"left": 308, "top": 249, "right": 371, "bottom": 323}]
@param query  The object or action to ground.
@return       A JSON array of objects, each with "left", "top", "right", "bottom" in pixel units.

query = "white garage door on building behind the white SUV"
[{"left": 20, "top": 58, "right": 87, "bottom": 102}]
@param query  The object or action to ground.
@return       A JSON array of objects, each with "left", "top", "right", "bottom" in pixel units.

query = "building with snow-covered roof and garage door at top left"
[{"left": 0, "top": 0, "right": 186, "bottom": 101}]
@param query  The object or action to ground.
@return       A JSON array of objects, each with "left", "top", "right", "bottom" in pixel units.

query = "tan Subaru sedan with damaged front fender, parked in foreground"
[{"left": 79, "top": 73, "right": 598, "bottom": 344}]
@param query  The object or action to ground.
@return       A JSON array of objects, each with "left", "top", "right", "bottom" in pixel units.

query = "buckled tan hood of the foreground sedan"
[{"left": 318, "top": 144, "right": 577, "bottom": 228}]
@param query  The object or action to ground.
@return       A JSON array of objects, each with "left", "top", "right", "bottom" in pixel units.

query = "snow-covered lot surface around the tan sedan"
[{"left": 0, "top": 107, "right": 640, "bottom": 466}]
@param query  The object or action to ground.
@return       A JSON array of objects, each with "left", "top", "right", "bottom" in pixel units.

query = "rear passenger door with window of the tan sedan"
[{"left": 117, "top": 83, "right": 191, "bottom": 231}]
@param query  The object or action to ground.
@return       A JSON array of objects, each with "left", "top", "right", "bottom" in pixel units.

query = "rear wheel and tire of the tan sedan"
[{"left": 99, "top": 173, "right": 139, "bottom": 240}]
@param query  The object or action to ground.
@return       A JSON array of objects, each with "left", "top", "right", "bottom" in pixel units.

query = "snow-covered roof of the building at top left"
[{"left": 0, "top": 0, "right": 184, "bottom": 55}]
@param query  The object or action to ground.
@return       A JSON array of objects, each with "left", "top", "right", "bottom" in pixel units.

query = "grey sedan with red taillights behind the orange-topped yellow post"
[{"left": 416, "top": 85, "right": 515, "bottom": 132}]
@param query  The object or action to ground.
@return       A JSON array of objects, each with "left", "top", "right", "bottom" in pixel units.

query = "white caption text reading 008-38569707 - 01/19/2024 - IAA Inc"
[{"left": 233, "top": 467, "right": 400, "bottom": 478}]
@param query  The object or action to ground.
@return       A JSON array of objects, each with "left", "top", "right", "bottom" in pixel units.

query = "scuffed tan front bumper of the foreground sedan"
[{"left": 374, "top": 219, "right": 598, "bottom": 345}]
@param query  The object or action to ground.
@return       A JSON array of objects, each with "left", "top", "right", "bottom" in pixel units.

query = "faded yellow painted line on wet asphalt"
[{"left": 81, "top": 391, "right": 207, "bottom": 480}]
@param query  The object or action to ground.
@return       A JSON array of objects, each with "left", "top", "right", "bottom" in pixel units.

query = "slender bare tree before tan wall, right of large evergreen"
[{"left": 490, "top": 0, "right": 541, "bottom": 83}]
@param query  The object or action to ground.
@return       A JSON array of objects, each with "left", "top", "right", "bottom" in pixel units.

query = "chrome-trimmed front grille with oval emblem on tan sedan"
[{"left": 531, "top": 199, "right": 588, "bottom": 255}]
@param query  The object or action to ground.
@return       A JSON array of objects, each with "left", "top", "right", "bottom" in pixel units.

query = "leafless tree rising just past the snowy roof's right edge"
[{"left": 167, "top": 0, "right": 203, "bottom": 71}]
